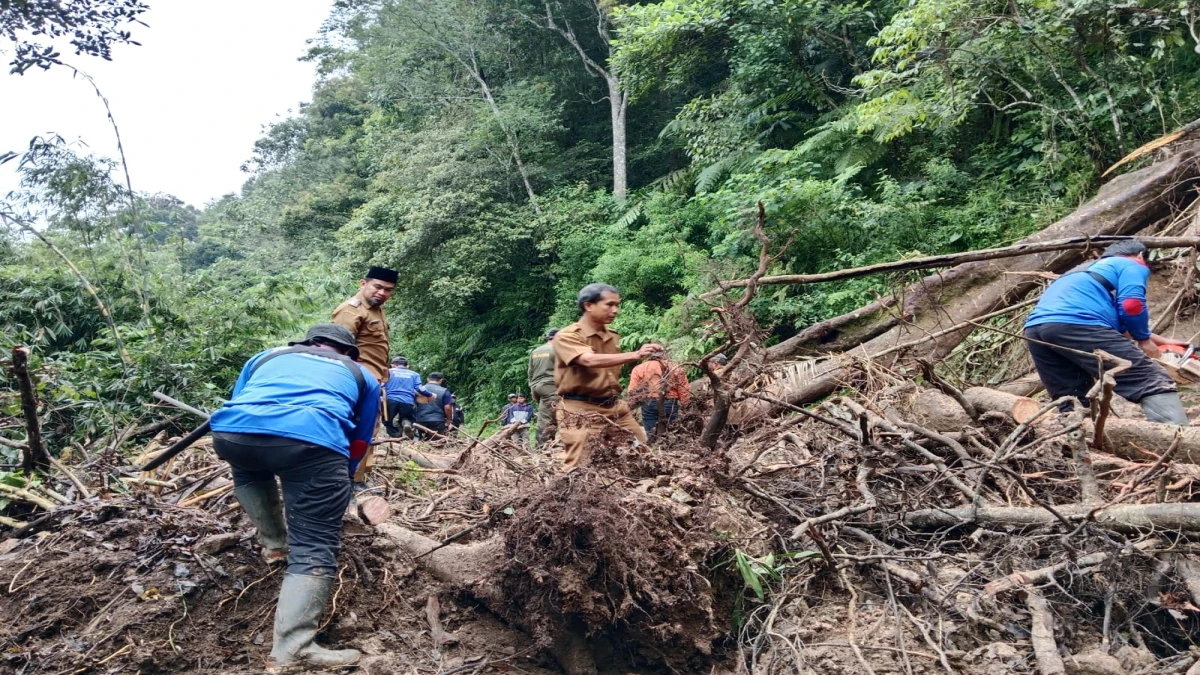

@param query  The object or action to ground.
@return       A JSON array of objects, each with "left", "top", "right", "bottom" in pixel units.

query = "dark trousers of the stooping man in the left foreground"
[{"left": 212, "top": 431, "right": 352, "bottom": 577}]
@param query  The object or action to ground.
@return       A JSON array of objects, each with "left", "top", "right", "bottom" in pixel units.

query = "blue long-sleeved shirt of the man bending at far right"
[{"left": 1025, "top": 257, "right": 1150, "bottom": 340}]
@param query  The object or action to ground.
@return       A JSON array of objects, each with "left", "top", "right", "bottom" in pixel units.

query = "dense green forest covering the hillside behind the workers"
[{"left": 0, "top": 0, "right": 1200, "bottom": 446}]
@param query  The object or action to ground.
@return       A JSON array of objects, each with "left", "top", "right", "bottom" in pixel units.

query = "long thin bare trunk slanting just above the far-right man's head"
[{"left": 700, "top": 234, "right": 1200, "bottom": 298}]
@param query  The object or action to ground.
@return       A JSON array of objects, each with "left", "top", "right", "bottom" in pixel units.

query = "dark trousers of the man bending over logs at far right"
[{"left": 1025, "top": 323, "right": 1176, "bottom": 406}]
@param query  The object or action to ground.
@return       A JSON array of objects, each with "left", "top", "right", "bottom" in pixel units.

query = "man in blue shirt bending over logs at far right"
[{"left": 1025, "top": 239, "right": 1189, "bottom": 426}]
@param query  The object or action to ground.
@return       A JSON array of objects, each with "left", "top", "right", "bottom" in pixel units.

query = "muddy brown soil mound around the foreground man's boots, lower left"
[{"left": 0, "top": 497, "right": 541, "bottom": 675}]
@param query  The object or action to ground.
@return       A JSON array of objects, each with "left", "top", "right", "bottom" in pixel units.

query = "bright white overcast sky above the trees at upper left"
[{"left": 0, "top": 0, "right": 332, "bottom": 207}]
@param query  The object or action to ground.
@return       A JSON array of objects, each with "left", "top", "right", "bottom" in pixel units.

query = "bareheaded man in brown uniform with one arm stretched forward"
[{"left": 553, "top": 283, "right": 662, "bottom": 471}]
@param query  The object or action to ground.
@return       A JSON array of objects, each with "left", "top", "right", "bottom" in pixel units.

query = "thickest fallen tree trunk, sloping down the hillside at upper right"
[{"left": 736, "top": 143, "right": 1200, "bottom": 422}]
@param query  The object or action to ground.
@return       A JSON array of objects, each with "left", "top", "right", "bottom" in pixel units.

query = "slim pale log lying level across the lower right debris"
[{"left": 902, "top": 502, "right": 1200, "bottom": 533}]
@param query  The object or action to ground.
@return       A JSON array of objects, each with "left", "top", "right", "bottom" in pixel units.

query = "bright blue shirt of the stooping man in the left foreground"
[{"left": 209, "top": 350, "right": 379, "bottom": 456}]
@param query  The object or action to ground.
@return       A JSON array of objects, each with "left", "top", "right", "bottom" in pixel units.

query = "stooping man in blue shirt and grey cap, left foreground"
[{"left": 210, "top": 323, "right": 379, "bottom": 671}]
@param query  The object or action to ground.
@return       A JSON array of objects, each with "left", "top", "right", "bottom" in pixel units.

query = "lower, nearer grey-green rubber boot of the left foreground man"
[{"left": 266, "top": 574, "right": 362, "bottom": 673}]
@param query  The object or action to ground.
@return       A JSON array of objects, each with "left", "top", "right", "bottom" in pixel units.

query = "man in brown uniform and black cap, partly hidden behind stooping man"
[{"left": 334, "top": 267, "right": 400, "bottom": 483}]
